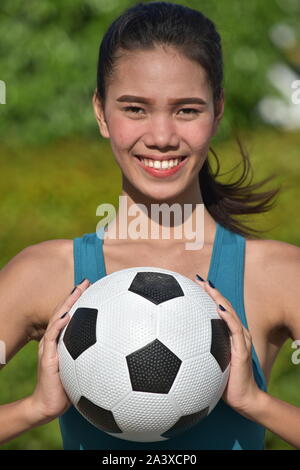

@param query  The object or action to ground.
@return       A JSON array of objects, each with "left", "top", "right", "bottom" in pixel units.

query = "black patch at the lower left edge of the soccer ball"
[{"left": 76, "top": 397, "right": 122, "bottom": 433}]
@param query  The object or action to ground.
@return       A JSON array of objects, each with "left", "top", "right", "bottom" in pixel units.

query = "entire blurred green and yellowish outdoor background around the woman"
[{"left": 0, "top": 0, "right": 300, "bottom": 449}]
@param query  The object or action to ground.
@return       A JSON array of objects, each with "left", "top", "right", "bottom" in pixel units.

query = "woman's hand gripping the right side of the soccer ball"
[{"left": 196, "top": 277, "right": 261, "bottom": 413}]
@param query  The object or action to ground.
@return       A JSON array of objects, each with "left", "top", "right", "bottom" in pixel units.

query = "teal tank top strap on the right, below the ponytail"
[{"left": 208, "top": 224, "right": 267, "bottom": 391}]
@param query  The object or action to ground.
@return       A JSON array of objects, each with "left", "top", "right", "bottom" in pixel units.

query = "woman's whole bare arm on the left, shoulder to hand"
[{"left": 0, "top": 241, "right": 81, "bottom": 444}]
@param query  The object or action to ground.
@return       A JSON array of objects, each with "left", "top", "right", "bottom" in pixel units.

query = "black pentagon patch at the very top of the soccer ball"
[{"left": 128, "top": 272, "right": 184, "bottom": 305}]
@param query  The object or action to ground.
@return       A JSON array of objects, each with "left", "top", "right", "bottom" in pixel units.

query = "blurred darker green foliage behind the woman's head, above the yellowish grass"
[{"left": 0, "top": 0, "right": 300, "bottom": 144}]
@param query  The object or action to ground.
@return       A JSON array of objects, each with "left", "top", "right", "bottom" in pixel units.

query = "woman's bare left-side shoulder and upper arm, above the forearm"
[{"left": 0, "top": 240, "right": 74, "bottom": 368}]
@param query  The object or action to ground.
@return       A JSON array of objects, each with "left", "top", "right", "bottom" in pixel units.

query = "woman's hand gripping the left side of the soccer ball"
[{"left": 31, "top": 279, "right": 90, "bottom": 424}]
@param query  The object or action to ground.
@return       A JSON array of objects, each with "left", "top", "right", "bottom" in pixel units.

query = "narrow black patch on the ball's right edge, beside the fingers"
[{"left": 210, "top": 319, "right": 231, "bottom": 372}]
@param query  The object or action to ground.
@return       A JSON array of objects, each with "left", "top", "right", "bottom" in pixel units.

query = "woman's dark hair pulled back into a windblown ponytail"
[{"left": 97, "top": 2, "right": 281, "bottom": 238}]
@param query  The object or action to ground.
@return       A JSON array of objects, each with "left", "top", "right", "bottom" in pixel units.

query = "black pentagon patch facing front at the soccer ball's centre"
[{"left": 126, "top": 339, "right": 182, "bottom": 393}]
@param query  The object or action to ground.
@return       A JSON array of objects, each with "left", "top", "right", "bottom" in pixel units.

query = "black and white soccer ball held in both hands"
[{"left": 58, "top": 267, "right": 230, "bottom": 442}]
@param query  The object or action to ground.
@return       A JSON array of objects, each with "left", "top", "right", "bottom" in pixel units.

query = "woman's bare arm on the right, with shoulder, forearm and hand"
[{"left": 197, "top": 242, "right": 300, "bottom": 449}]
